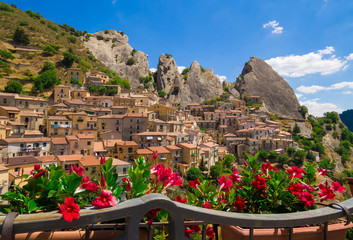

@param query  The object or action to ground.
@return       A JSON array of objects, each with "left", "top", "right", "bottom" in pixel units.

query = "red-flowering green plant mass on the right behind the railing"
[{"left": 187, "top": 154, "right": 345, "bottom": 213}]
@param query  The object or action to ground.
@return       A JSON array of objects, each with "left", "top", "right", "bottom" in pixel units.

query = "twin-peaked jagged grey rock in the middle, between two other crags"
[{"left": 155, "top": 54, "right": 223, "bottom": 107}]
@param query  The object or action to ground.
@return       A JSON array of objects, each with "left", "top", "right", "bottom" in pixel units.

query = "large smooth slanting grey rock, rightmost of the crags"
[{"left": 235, "top": 57, "right": 303, "bottom": 119}]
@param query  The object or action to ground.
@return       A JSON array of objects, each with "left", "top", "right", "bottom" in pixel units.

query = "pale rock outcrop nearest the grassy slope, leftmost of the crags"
[{"left": 84, "top": 30, "right": 148, "bottom": 87}]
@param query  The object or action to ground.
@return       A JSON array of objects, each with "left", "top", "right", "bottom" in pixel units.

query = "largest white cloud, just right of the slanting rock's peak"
[{"left": 266, "top": 46, "right": 353, "bottom": 77}]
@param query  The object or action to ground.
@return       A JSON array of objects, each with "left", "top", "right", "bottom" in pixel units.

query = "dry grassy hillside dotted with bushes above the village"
[{"left": 0, "top": 2, "right": 104, "bottom": 95}]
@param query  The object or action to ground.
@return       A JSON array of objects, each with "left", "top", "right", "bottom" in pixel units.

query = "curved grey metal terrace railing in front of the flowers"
[{"left": 0, "top": 194, "right": 353, "bottom": 240}]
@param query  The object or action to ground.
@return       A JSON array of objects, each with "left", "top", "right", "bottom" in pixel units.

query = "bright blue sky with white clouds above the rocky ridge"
[{"left": 6, "top": 0, "right": 353, "bottom": 115}]
